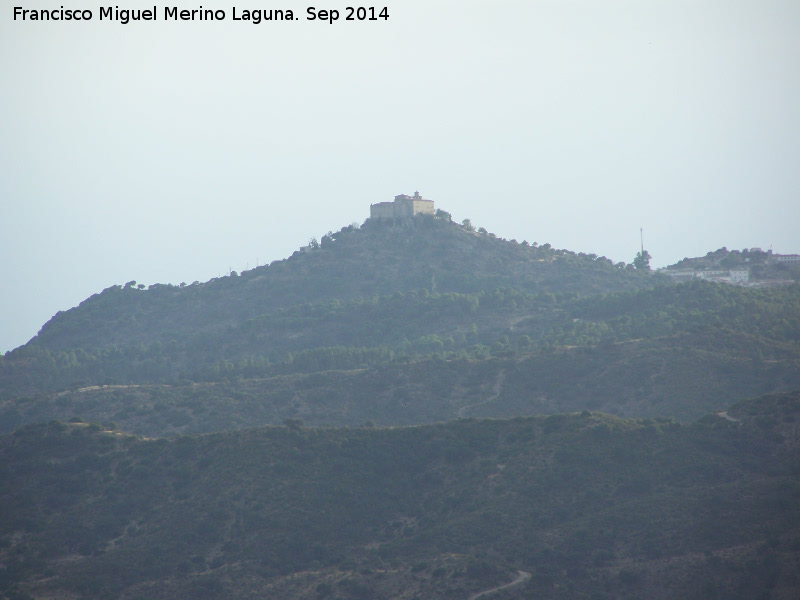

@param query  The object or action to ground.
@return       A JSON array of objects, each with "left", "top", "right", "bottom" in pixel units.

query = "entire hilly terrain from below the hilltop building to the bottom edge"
[{"left": 0, "top": 213, "right": 800, "bottom": 600}]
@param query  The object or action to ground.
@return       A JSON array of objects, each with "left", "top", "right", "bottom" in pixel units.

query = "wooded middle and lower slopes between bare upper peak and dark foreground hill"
[{"left": 0, "top": 282, "right": 800, "bottom": 436}]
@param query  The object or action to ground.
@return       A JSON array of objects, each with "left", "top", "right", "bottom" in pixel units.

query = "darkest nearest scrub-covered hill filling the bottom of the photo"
[{"left": 0, "top": 393, "right": 800, "bottom": 600}]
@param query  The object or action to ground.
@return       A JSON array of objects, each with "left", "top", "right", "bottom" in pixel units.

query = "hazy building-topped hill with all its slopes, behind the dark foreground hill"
[{"left": 0, "top": 218, "right": 800, "bottom": 436}]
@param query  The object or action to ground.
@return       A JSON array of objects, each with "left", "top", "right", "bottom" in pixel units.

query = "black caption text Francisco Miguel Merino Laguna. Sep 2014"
[{"left": 14, "top": 6, "right": 389, "bottom": 25}]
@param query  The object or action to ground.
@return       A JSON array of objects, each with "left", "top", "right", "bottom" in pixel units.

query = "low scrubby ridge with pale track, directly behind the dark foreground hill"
[{"left": 0, "top": 335, "right": 800, "bottom": 437}]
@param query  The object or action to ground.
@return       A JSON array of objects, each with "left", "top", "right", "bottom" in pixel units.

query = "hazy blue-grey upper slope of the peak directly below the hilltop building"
[{"left": 25, "top": 217, "right": 650, "bottom": 352}]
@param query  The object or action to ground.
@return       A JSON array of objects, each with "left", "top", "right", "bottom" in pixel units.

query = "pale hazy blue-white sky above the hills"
[{"left": 0, "top": 0, "right": 800, "bottom": 352}]
